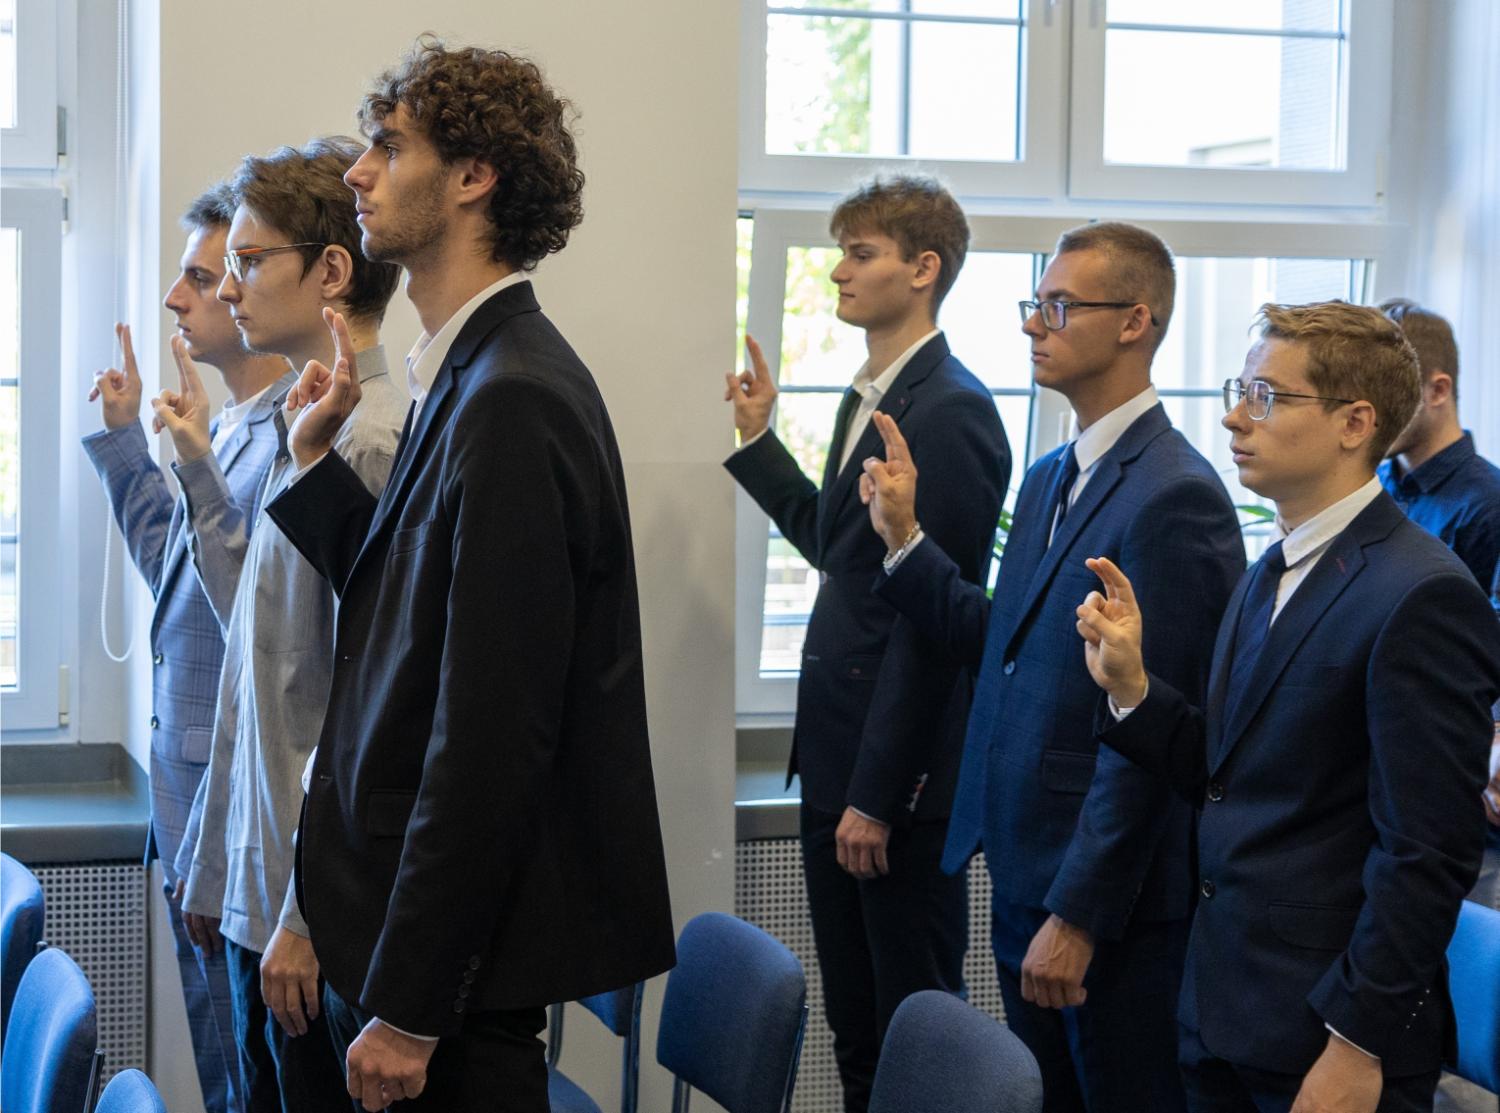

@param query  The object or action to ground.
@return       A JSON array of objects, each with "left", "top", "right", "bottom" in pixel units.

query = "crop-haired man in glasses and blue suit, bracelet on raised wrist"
[{"left": 863, "top": 224, "right": 1245, "bottom": 1113}]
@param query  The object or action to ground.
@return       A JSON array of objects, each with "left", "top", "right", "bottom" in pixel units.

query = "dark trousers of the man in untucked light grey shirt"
[{"left": 224, "top": 939, "right": 350, "bottom": 1113}]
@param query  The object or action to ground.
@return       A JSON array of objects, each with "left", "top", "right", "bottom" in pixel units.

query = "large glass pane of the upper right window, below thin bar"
[{"left": 1104, "top": 30, "right": 1344, "bottom": 170}]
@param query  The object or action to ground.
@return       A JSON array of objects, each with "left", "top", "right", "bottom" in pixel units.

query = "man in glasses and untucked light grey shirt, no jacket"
[{"left": 148, "top": 137, "right": 408, "bottom": 1113}]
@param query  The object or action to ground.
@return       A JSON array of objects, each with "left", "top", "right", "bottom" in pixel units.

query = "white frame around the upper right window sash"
[{"left": 1068, "top": 0, "right": 1395, "bottom": 209}]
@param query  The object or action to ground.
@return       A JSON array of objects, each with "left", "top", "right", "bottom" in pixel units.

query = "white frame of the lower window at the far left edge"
[{"left": 0, "top": 188, "right": 68, "bottom": 734}]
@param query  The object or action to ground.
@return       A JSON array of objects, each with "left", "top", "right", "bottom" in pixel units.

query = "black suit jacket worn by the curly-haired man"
[{"left": 269, "top": 282, "right": 674, "bottom": 1035}]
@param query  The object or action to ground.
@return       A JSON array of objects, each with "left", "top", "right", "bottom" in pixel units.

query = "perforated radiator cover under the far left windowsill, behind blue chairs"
[{"left": 32, "top": 863, "right": 149, "bottom": 1082}]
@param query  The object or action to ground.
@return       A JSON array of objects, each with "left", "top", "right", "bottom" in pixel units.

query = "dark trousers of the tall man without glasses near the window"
[{"left": 803, "top": 804, "right": 969, "bottom": 1113}]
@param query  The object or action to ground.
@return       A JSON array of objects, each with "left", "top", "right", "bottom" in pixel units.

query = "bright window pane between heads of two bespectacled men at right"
[{"left": 1152, "top": 257, "right": 1359, "bottom": 393}]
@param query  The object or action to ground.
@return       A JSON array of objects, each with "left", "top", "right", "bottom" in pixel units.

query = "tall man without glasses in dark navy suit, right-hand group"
[{"left": 725, "top": 176, "right": 1011, "bottom": 1113}]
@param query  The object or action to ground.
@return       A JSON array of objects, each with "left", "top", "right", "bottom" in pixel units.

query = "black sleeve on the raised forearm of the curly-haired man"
[{"left": 266, "top": 452, "right": 377, "bottom": 593}]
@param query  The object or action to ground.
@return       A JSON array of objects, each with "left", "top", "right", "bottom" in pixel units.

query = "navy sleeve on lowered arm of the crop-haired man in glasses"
[{"left": 1044, "top": 479, "right": 1245, "bottom": 939}]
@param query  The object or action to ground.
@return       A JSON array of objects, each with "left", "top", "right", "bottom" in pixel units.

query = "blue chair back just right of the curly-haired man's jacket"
[{"left": 654, "top": 912, "right": 807, "bottom": 1113}]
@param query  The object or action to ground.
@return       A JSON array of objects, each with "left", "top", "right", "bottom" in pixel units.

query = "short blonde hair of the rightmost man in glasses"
[{"left": 1256, "top": 302, "right": 1422, "bottom": 464}]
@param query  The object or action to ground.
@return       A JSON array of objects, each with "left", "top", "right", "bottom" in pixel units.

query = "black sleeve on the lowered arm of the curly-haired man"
[{"left": 360, "top": 377, "right": 600, "bottom": 1037}]
